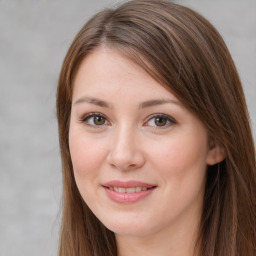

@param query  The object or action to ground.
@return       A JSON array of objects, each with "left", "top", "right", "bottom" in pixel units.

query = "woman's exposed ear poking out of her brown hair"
[{"left": 206, "top": 140, "right": 227, "bottom": 165}]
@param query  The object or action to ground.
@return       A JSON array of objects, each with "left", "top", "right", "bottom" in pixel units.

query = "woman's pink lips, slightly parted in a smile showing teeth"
[{"left": 102, "top": 180, "right": 156, "bottom": 203}]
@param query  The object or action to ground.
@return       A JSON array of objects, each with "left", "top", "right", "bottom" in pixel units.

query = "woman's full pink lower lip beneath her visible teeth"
[{"left": 104, "top": 187, "right": 155, "bottom": 204}]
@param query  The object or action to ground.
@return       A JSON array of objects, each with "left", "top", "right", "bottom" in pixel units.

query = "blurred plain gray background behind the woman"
[{"left": 0, "top": 0, "right": 256, "bottom": 256}]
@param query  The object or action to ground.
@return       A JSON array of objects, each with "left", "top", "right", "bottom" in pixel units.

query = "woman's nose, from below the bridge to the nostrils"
[{"left": 107, "top": 125, "right": 145, "bottom": 171}]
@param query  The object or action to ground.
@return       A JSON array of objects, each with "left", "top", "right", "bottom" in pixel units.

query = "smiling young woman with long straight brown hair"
[{"left": 57, "top": 0, "right": 256, "bottom": 256}]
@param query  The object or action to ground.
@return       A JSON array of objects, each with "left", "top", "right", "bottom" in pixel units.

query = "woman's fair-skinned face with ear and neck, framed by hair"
[{"left": 69, "top": 47, "right": 224, "bottom": 256}]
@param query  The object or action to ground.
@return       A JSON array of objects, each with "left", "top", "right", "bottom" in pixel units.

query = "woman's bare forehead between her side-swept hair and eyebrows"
[{"left": 73, "top": 47, "right": 178, "bottom": 100}]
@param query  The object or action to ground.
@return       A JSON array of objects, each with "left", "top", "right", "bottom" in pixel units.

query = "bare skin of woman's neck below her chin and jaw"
[{"left": 116, "top": 200, "right": 201, "bottom": 256}]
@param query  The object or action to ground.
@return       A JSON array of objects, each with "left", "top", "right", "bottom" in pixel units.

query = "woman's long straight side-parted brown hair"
[{"left": 57, "top": 0, "right": 256, "bottom": 256}]
